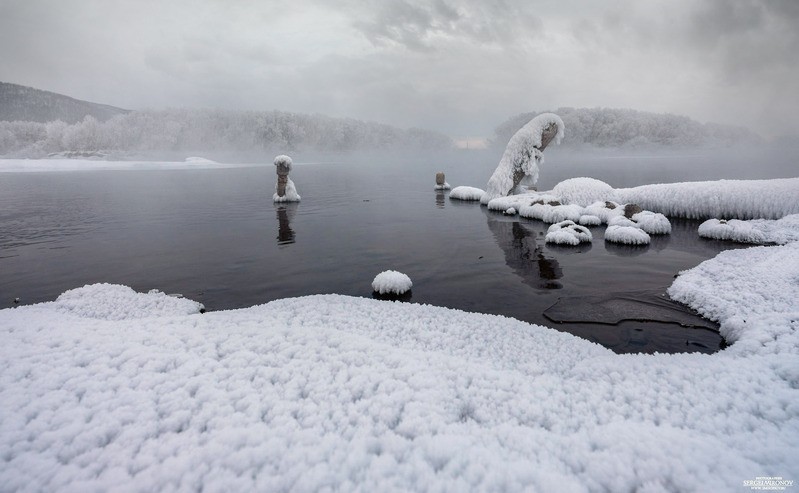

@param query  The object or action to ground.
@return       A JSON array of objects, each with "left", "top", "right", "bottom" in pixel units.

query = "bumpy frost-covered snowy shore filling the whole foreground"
[{"left": 0, "top": 243, "right": 799, "bottom": 491}]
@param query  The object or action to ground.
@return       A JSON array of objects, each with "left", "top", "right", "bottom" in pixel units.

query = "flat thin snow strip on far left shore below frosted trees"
[{"left": 0, "top": 158, "right": 242, "bottom": 173}]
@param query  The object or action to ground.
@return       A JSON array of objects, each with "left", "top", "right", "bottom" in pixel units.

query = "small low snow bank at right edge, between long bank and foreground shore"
[{"left": 698, "top": 214, "right": 799, "bottom": 245}]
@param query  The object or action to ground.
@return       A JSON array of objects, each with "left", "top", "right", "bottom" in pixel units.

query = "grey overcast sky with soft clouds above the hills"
[{"left": 0, "top": 0, "right": 799, "bottom": 138}]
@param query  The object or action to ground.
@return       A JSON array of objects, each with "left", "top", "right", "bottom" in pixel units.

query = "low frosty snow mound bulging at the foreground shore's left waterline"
[{"left": 54, "top": 284, "right": 203, "bottom": 320}]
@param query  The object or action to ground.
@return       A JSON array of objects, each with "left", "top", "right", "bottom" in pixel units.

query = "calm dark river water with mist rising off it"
[{"left": 0, "top": 151, "right": 788, "bottom": 352}]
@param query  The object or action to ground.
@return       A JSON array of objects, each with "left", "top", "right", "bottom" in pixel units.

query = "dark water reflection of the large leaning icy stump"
[{"left": 486, "top": 213, "right": 563, "bottom": 289}]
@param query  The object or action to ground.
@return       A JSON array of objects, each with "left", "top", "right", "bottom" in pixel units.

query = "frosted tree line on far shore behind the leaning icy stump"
[{"left": 492, "top": 108, "right": 763, "bottom": 148}]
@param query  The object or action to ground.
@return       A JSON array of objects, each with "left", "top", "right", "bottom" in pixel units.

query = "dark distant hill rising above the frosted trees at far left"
[{"left": 0, "top": 82, "right": 129, "bottom": 123}]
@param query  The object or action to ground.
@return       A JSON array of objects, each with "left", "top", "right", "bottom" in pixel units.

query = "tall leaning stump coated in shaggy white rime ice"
[{"left": 481, "top": 113, "right": 564, "bottom": 204}]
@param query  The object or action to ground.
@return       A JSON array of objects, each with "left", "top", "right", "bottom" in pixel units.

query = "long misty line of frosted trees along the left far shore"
[{"left": 0, "top": 109, "right": 452, "bottom": 157}]
